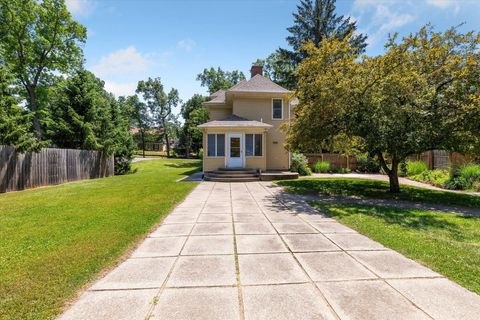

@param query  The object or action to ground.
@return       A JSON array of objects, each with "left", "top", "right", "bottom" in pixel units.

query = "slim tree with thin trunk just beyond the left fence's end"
[{"left": 119, "top": 95, "right": 152, "bottom": 158}]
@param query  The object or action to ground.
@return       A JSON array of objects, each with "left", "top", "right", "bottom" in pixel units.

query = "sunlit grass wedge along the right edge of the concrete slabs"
[{"left": 312, "top": 202, "right": 480, "bottom": 294}]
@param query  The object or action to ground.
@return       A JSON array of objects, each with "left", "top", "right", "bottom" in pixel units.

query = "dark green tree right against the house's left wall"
[{"left": 180, "top": 94, "right": 208, "bottom": 157}]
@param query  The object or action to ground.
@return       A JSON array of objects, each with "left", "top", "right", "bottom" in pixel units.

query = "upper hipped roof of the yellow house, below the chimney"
[{"left": 206, "top": 74, "right": 292, "bottom": 104}]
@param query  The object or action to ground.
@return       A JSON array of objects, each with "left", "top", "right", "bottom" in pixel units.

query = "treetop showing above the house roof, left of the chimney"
[{"left": 197, "top": 67, "right": 245, "bottom": 94}]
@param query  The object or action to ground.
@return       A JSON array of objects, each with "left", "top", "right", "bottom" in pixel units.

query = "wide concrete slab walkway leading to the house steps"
[{"left": 61, "top": 182, "right": 480, "bottom": 320}]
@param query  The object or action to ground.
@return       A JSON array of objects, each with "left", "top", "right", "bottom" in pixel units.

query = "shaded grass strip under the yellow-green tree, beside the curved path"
[{"left": 277, "top": 178, "right": 480, "bottom": 208}]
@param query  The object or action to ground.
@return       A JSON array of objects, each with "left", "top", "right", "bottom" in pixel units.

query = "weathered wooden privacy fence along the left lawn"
[{"left": 0, "top": 145, "right": 114, "bottom": 193}]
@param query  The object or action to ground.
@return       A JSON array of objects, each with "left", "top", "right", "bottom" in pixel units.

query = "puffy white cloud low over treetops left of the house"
[{"left": 91, "top": 46, "right": 154, "bottom": 77}]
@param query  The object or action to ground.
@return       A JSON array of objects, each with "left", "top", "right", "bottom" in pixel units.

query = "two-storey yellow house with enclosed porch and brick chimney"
[{"left": 199, "top": 66, "right": 296, "bottom": 181}]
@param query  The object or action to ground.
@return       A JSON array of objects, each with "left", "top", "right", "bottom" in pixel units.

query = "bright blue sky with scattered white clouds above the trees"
[{"left": 66, "top": 0, "right": 480, "bottom": 110}]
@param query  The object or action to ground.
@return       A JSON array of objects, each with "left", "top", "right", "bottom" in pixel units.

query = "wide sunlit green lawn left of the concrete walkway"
[{"left": 0, "top": 159, "right": 200, "bottom": 319}]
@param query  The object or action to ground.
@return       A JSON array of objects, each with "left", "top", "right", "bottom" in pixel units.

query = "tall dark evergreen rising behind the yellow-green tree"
[{"left": 265, "top": 0, "right": 367, "bottom": 89}]
